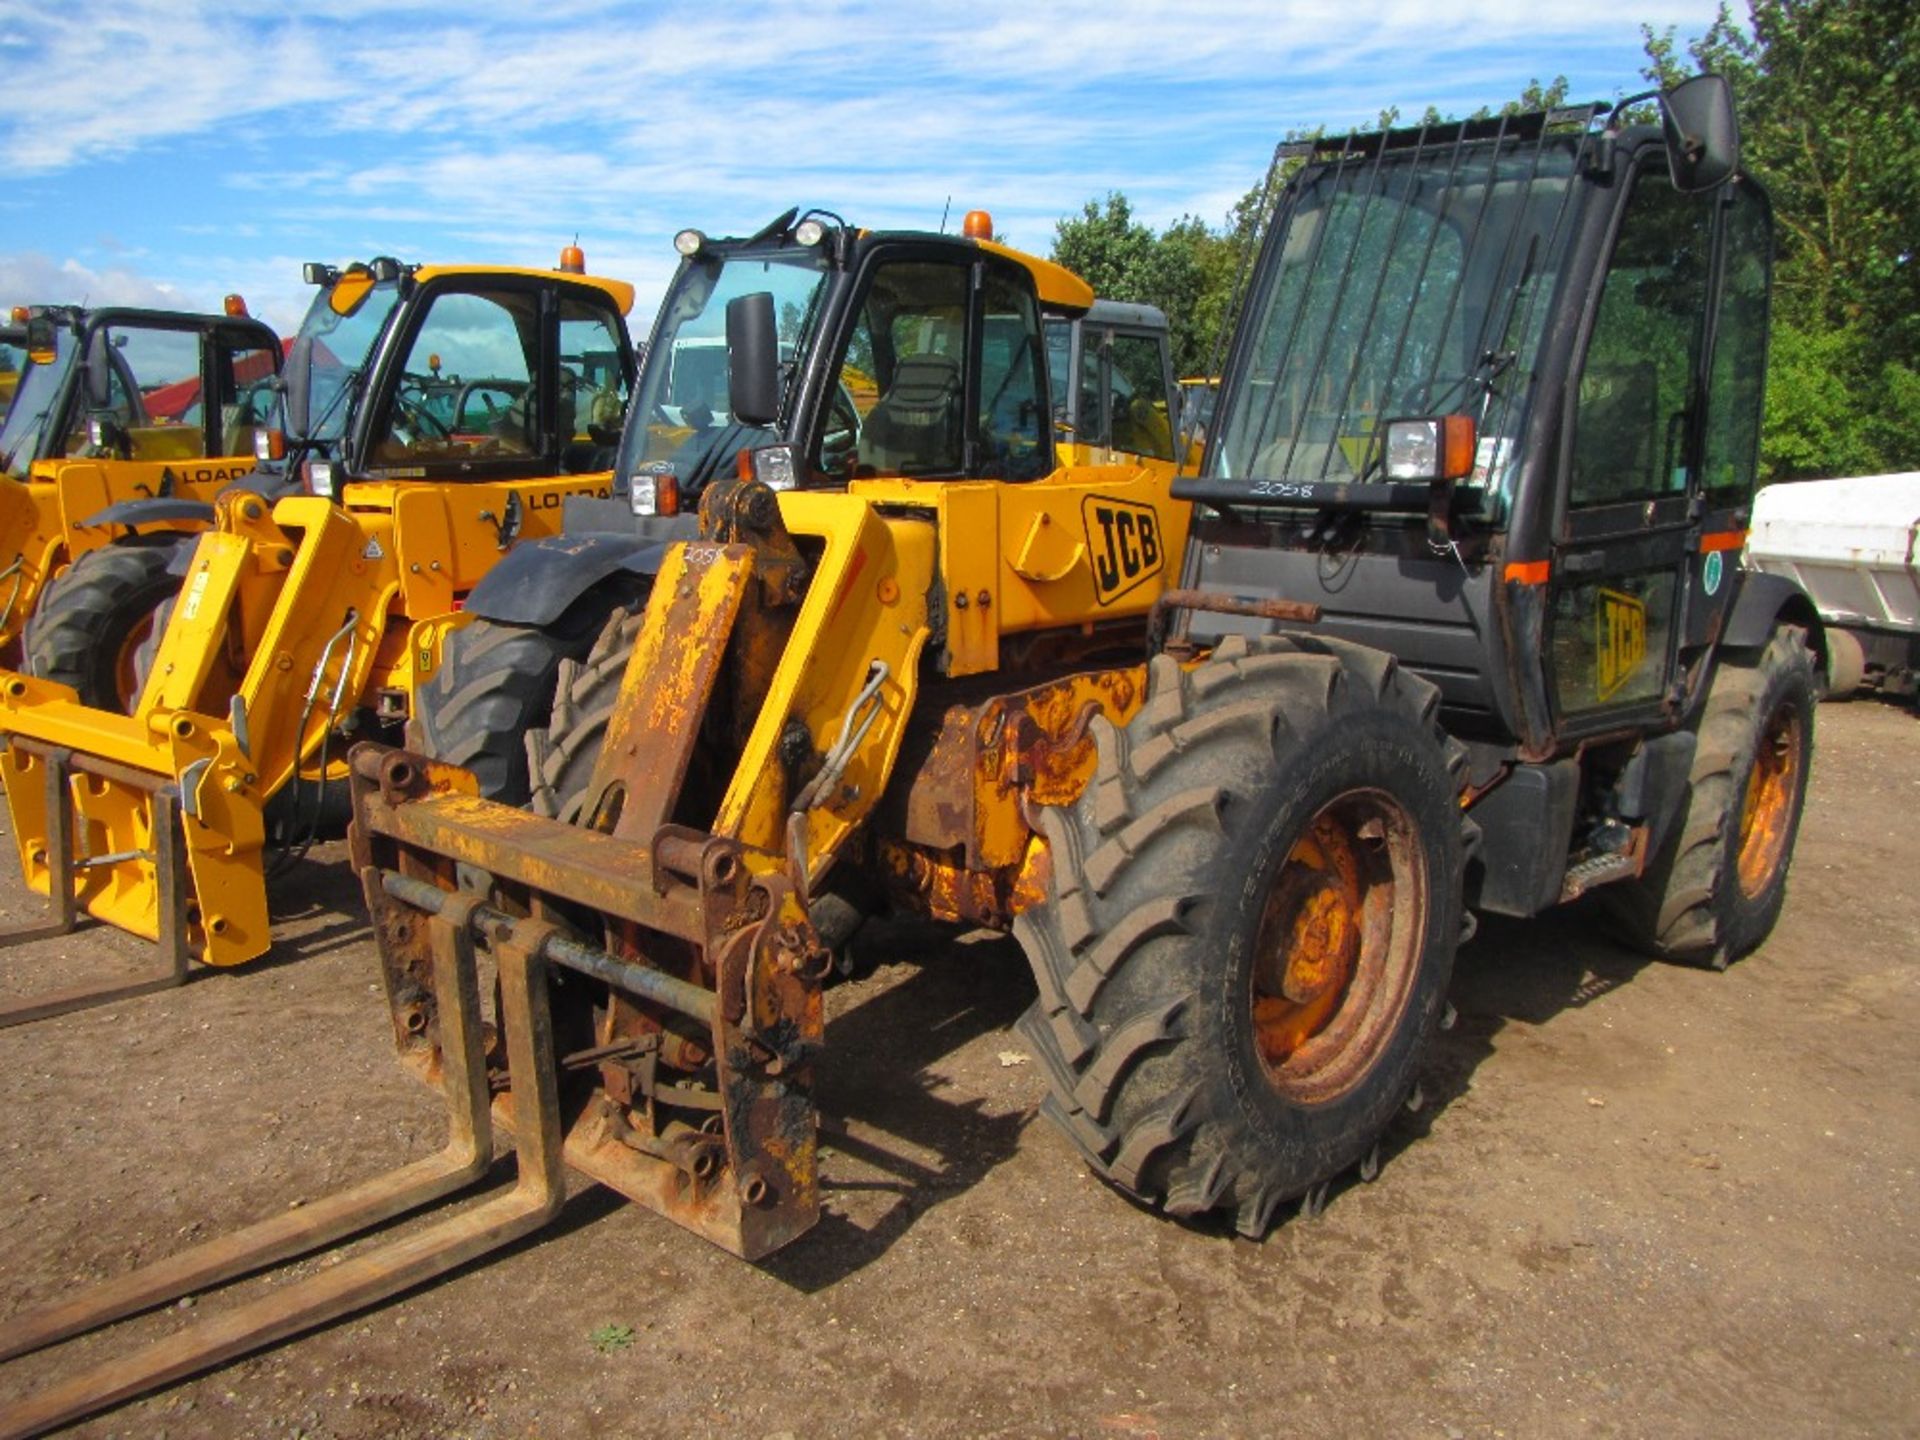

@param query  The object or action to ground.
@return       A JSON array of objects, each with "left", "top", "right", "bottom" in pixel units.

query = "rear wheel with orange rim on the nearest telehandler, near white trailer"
[{"left": 1601, "top": 628, "right": 1818, "bottom": 970}]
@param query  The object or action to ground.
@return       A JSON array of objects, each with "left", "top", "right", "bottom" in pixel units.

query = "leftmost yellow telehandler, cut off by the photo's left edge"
[{"left": 0, "top": 296, "right": 280, "bottom": 672}]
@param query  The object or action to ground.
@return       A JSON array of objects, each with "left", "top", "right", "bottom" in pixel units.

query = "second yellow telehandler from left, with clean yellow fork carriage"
[{"left": 0, "top": 247, "right": 634, "bottom": 1025}]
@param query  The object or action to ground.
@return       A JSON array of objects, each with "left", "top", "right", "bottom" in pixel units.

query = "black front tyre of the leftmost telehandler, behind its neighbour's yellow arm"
[{"left": 23, "top": 536, "right": 194, "bottom": 714}]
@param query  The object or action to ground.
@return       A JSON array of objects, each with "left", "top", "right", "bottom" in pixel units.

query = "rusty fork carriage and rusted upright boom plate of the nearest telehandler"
[{"left": 353, "top": 484, "right": 828, "bottom": 1258}]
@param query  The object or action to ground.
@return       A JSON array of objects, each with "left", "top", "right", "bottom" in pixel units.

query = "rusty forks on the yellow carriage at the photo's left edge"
[{"left": 0, "top": 735, "right": 190, "bottom": 1029}]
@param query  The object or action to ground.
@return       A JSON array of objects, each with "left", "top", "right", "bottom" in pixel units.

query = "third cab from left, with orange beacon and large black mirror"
[{"left": 616, "top": 209, "right": 1092, "bottom": 516}]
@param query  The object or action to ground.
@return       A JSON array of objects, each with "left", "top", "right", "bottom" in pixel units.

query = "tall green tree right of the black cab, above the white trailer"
[{"left": 1644, "top": 0, "right": 1920, "bottom": 478}]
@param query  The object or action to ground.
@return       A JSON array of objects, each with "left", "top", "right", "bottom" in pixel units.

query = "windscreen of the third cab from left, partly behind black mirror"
[{"left": 620, "top": 246, "right": 828, "bottom": 493}]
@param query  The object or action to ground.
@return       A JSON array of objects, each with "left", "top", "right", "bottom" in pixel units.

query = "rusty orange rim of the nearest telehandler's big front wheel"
[{"left": 1250, "top": 789, "right": 1427, "bottom": 1102}]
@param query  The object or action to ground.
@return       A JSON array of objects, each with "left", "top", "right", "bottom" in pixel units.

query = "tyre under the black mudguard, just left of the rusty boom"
[{"left": 407, "top": 611, "right": 599, "bottom": 804}]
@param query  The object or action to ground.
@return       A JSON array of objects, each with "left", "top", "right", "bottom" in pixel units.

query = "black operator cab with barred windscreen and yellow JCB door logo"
[{"left": 1175, "top": 77, "right": 1772, "bottom": 768}]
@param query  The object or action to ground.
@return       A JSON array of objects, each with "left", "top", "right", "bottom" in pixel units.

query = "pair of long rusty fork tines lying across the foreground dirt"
[{"left": 0, "top": 895, "right": 566, "bottom": 1440}]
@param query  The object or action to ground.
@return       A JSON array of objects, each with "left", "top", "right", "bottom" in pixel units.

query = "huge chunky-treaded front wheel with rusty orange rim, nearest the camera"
[{"left": 1016, "top": 636, "right": 1473, "bottom": 1236}]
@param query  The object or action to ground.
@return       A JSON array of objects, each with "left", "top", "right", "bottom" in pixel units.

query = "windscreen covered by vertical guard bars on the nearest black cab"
[{"left": 1210, "top": 129, "right": 1580, "bottom": 513}]
